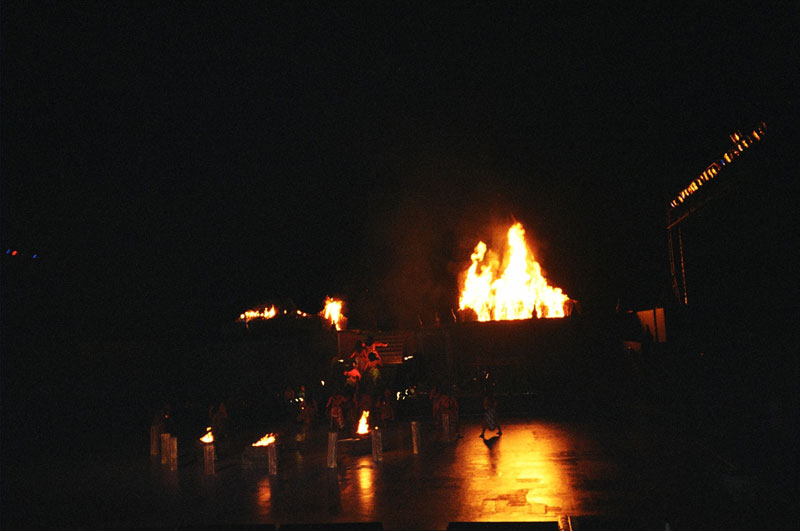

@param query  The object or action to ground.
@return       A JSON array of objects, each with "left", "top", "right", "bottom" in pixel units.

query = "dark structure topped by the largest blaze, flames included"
[{"left": 324, "top": 223, "right": 583, "bottom": 406}]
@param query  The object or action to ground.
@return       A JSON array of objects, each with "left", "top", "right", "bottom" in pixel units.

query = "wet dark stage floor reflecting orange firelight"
[{"left": 3, "top": 417, "right": 790, "bottom": 530}]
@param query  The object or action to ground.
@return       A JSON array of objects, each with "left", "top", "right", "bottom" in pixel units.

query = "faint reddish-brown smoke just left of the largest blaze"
[{"left": 360, "top": 169, "right": 516, "bottom": 328}]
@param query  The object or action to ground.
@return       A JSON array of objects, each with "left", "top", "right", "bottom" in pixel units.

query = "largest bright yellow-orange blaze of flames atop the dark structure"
[{"left": 458, "top": 223, "right": 569, "bottom": 321}]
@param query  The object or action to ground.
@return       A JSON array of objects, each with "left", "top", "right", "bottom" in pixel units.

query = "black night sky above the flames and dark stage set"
[{"left": 0, "top": 2, "right": 800, "bottom": 340}]
